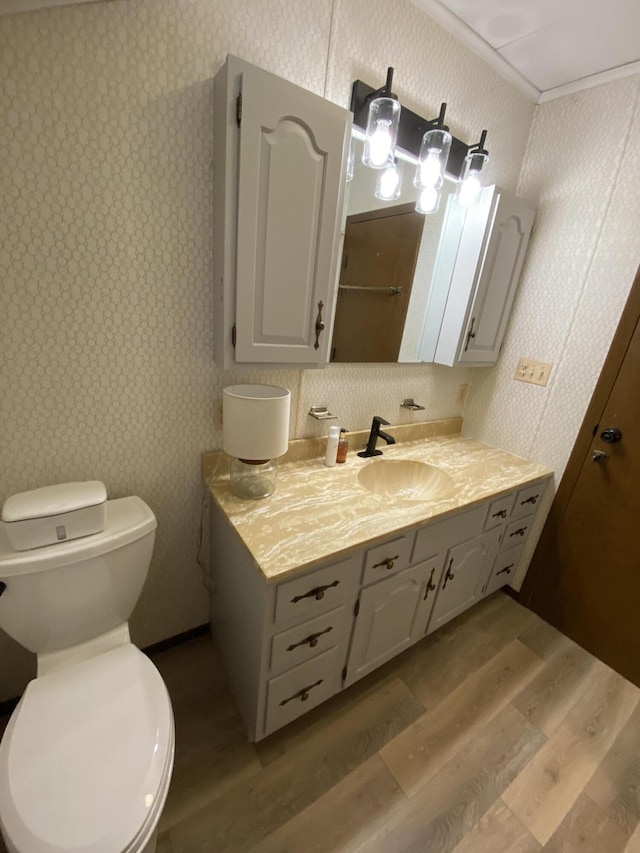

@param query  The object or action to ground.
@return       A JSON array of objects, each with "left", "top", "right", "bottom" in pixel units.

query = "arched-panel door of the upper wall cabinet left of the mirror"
[{"left": 235, "top": 61, "right": 351, "bottom": 367}]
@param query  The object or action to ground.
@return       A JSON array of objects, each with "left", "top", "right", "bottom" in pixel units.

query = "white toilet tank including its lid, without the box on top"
[{"left": 0, "top": 497, "right": 157, "bottom": 654}]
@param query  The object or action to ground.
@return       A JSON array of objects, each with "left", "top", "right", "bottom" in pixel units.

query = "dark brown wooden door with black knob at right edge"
[{"left": 523, "top": 290, "right": 640, "bottom": 686}]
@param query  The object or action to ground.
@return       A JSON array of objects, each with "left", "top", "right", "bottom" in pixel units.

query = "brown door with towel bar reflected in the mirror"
[{"left": 331, "top": 204, "right": 425, "bottom": 362}]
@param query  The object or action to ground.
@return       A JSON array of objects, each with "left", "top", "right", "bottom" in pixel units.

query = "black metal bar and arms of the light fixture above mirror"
[{"left": 351, "top": 75, "right": 487, "bottom": 180}]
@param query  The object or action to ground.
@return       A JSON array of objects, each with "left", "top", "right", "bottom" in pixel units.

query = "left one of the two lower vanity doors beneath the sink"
[{"left": 344, "top": 558, "right": 442, "bottom": 687}]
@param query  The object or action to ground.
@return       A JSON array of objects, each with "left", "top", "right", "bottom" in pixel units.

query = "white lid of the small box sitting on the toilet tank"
[{"left": 2, "top": 480, "right": 107, "bottom": 524}]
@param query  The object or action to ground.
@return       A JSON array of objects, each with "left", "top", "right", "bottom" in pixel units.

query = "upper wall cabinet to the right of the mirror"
[{"left": 421, "top": 186, "right": 535, "bottom": 367}]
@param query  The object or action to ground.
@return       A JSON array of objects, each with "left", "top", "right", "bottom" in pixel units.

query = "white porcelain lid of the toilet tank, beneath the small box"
[{"left": 0, "top": 497, "right": 157, "bottom": 580}]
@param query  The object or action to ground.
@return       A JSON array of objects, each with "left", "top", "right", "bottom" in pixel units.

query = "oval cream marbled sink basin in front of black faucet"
[{"left": 358, "top": 459, "right": 454, "bottom": 501}]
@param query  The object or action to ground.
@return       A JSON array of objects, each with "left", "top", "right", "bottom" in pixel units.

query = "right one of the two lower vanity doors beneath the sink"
[{"left": 428, "top": 528, "right": 502, "bottom": 634}]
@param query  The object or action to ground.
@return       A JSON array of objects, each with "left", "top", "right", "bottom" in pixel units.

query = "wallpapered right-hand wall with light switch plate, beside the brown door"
[{"left": 464, "top": 75, "right": 640, "bottom": 584}]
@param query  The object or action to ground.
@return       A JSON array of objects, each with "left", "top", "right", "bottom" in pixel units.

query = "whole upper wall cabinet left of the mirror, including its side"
[{"left": 213, "top": 56, "right": 352, "bottom": 368}]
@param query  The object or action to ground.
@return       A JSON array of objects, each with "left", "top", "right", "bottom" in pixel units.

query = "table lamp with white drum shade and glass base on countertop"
[{"left": 222, "top": 385, "right": 291, "bottom": 500}]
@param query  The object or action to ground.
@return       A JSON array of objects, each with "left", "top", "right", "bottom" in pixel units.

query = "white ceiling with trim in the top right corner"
[{"left": 413, "top": 0, "right": 640, "bottom": 101}]
